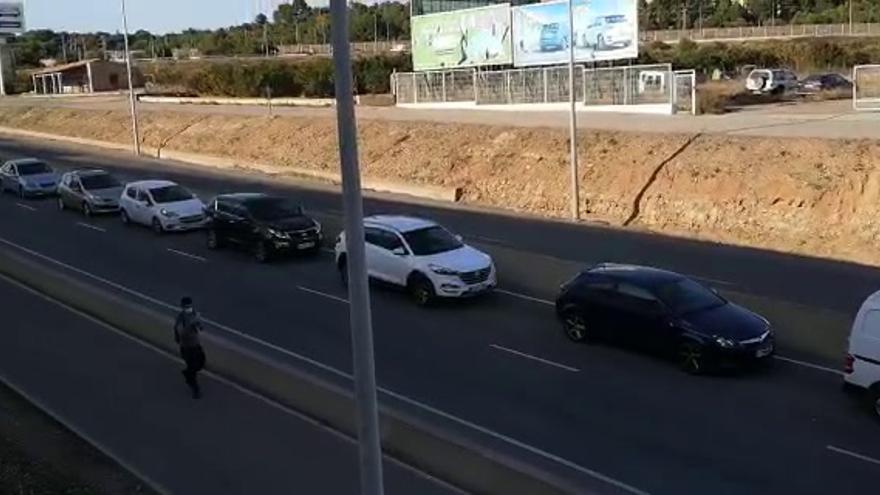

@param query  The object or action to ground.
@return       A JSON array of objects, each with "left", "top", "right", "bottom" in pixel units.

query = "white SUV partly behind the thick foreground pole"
[{"left": 336, "top": 215, "right": 496, "bottom": 305}]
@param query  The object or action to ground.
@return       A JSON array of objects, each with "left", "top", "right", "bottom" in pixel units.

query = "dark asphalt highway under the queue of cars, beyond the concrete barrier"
[{"left": 0, "top": 139, "right": 880, "bottom": 494}]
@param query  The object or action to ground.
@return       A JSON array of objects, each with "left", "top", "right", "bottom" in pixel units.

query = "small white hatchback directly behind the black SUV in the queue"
[{"left": 119, "top": 180, "right": 207, "bottom": 234}]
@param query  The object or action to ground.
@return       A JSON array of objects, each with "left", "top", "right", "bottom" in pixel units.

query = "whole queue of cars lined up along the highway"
[{"left": 0, "top": 158, "right": 880, "bottom": 418}]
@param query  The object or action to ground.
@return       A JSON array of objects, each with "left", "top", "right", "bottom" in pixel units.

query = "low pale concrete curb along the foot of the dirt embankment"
[{"left": 0, "top": 127, "right": 461, "bottom": 203}]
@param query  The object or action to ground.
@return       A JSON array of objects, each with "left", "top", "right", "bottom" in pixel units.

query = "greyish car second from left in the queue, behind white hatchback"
[{"left": 58, "top": 169, "right": 122, "bottom": 217}]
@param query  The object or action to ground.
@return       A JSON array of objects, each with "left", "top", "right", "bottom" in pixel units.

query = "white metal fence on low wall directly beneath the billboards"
[{"left": 391, "top": 64, "right": 680, "bottom": 111}]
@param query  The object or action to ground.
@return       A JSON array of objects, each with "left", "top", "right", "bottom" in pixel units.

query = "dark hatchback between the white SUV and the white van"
[{"left": 556, "top": 263, "right": 775, "bottom": 374}]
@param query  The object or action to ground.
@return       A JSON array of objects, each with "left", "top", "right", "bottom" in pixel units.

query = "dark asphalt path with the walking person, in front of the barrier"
[{"left": 0, "top": 277, "right": 461, "bottom": 495}]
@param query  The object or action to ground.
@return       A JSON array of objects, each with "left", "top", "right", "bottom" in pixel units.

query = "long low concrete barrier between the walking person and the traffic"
[{"left": 0, "top": 247, "right": 591, "bottom": 495}]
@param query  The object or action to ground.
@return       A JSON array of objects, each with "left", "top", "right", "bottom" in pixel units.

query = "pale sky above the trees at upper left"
[{"left": 24, "top": 0, "right": 327, "bottom": 33}]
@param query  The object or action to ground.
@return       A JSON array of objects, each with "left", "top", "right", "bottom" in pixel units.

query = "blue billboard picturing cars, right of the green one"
[{"left": 512, "top": 0, "right": 639, "bottom": 66}]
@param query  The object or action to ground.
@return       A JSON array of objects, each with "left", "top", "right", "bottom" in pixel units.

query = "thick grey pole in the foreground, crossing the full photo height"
[{"left": 330, "top": 0, "right": 384, "bottom": 495}]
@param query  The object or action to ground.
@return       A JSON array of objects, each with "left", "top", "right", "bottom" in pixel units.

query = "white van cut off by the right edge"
[{"left": 844, "top": 292, "right": 880, "bottom": 418}]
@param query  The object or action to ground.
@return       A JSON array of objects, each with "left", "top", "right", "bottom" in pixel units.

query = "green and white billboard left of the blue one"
[{"left": 411, "top": 3, "right": 513, "bottom": 71}]
